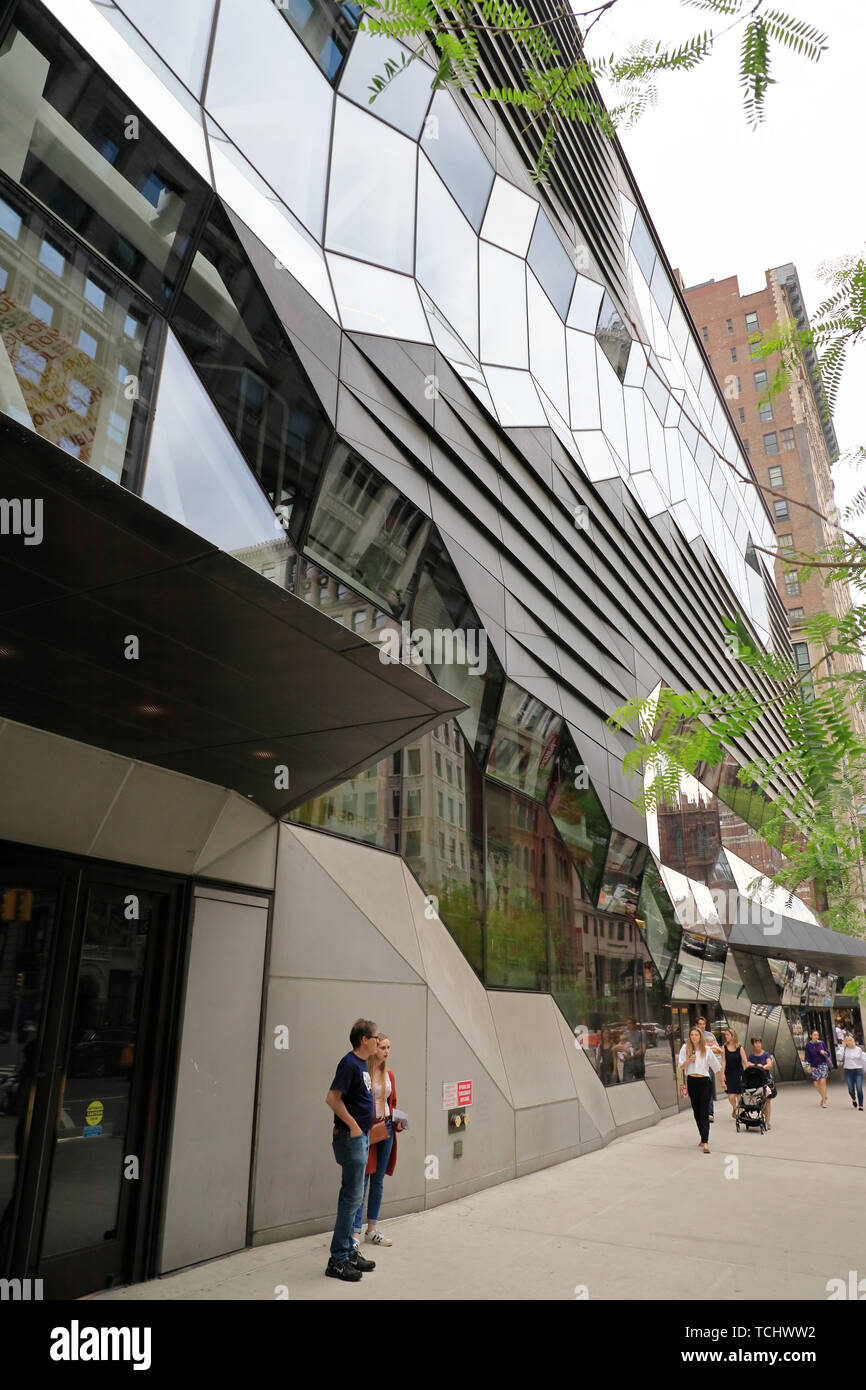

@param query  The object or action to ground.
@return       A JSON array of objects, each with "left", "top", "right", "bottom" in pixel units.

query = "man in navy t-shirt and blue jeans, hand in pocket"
[{"left": 325, "top": 1019, "right": 379, "bottom": 1284}]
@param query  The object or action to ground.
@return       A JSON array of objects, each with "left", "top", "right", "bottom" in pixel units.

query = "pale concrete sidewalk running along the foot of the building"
[{"left": 97, "top": 1077, "right": 866, "bottom": 1301}]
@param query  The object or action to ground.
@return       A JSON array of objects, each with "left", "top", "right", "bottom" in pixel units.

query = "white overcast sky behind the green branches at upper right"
[{"left": 583, "top": 0, "right": 866, "bottom": 517}]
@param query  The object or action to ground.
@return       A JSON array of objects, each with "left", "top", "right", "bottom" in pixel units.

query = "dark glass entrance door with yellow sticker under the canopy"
[{"left": 0, "top": 847, "right": 182, "bottom": 1298}]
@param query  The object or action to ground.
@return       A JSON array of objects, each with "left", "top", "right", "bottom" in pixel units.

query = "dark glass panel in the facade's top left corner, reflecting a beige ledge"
[{"left": 0, "top": 4, "right": 207, "bottom": 306}]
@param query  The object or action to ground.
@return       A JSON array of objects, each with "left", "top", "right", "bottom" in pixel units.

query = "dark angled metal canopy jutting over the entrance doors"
[{"left": 0, "top": 417, "right": 466, "bottom": 816}]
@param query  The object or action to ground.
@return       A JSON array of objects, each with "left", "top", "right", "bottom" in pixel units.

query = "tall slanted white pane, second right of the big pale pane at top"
[{"left": 414, "top": 156, "right": 478, "bottom": 353}]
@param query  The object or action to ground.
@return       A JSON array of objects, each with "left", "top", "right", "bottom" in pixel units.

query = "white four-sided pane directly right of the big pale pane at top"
[{"left": 325, "top": 99, "right": 419, "bottom": 271}]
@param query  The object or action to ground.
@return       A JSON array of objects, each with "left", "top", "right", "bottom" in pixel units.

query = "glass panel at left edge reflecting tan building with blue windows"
[{"left": 0, "top": 186, "right": 158, "bottom": 487}]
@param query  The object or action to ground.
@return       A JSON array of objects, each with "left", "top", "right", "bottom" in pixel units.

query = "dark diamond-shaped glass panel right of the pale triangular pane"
[{"left": 172, "top": 198, "right": 332, "bottom": 535}]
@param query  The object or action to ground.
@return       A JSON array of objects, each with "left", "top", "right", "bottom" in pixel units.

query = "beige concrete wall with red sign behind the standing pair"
[{"left": 253, "top": 826, "right": 667, "bottom": 1244}]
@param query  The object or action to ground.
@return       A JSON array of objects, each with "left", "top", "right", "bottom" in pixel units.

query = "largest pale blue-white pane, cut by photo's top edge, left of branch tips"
[{"left": 204, "top": 0, "right": 334, "bottom": 236}]
